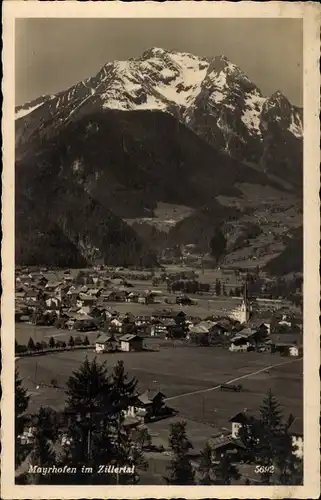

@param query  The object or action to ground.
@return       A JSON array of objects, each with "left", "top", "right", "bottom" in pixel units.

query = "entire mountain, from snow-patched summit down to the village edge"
[{"left": 15, "top": 48, "right": 303, "bottom": 274}]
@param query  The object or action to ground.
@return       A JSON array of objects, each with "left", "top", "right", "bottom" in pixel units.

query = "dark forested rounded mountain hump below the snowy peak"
[{"left": 16, "top": 110, "right": 300, "bottom": 265}]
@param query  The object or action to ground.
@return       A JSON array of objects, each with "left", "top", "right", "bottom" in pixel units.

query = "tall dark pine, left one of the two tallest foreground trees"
[{"left": 62, "top": 358, "right": 116, "bottom": 484}]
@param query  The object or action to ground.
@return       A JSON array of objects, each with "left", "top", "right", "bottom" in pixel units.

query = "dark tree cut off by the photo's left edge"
[{"left": 15, "top": 369, "right": 29, "bottom": 468}]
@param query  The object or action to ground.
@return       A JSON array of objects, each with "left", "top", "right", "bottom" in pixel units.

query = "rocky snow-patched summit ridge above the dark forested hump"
[{"left": 16, "top": 48, "right": 302, "bottom": 181}]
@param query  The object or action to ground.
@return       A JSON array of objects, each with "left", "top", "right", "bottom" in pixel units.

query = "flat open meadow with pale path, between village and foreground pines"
[{"left": 16, "top": 346, "right": 303, "bottom": 433}]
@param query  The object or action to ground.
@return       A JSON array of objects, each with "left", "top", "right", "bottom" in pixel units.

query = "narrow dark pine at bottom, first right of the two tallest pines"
[{"left": 167, "top": 421, "right": 194, "bottom": 485}]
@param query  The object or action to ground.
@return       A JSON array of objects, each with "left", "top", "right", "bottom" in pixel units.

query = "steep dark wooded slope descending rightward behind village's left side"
[{"left": 15, "top": 120, "right": 160, "bottom": 267}]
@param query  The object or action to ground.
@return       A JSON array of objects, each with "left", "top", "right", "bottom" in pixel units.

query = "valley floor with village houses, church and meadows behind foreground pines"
[{"left": 15, "top": 263, "right": 303, "bottom": 484}]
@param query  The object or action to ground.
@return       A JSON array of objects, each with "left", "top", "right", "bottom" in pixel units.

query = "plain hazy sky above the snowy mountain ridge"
[{"left": 15, "top": 19, "right": 303, "bottom": 106}]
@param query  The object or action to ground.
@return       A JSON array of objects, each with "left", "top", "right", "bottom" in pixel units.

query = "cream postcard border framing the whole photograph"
[{"left": 1, "top": 1, "right": 320, "bottom": 500}]
